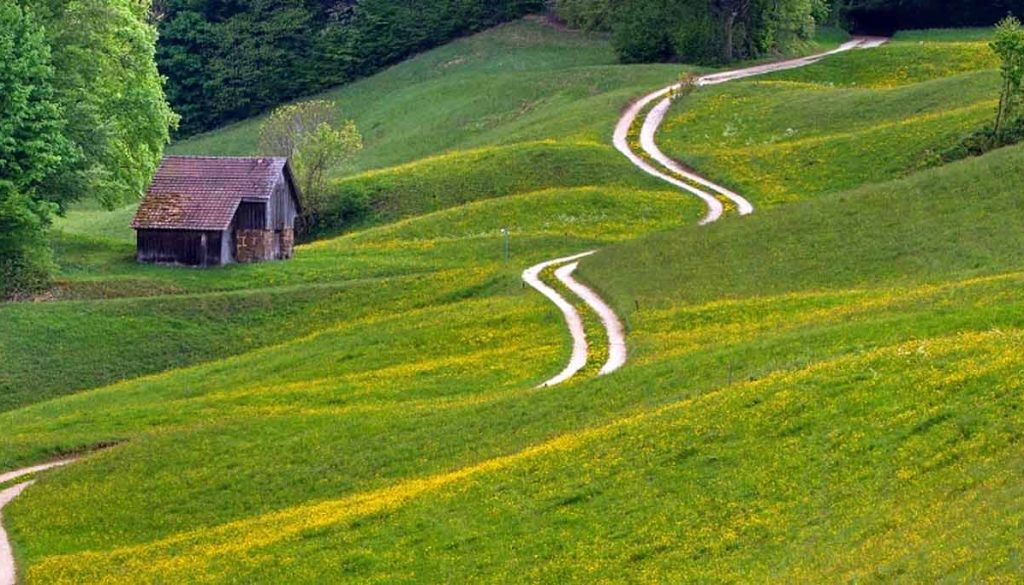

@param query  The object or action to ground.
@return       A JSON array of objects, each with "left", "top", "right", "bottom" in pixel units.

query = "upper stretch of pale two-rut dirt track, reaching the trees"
[{"left": 613, "top": 37, "right": 888, "bottom": 225}]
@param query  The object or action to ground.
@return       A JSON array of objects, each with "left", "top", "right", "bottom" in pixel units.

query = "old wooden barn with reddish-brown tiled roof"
[{"left": 132, "top": 157, "right": 301, "bottom": 266}]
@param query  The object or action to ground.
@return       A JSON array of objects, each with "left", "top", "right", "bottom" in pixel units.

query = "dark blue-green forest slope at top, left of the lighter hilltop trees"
[{"left": 155, "top": 0, "right": 543, "bottom": 134}]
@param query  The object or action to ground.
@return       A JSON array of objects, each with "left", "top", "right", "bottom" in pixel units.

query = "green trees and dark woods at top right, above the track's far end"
[{"left": 549, "top": 0, "right": 1024, "bottom": 64}]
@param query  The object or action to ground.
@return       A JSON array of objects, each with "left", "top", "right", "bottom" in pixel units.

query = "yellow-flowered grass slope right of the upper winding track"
[{"left": 658, "top": 32, "right": 999, "bottom": 207}]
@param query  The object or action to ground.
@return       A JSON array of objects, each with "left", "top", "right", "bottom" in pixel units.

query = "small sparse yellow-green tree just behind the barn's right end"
[{"left": 260, "top": 99, "right": 362, "bottom": 233}]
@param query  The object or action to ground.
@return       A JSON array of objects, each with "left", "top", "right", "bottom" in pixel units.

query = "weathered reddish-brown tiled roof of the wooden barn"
[{"left": 131, "top": 157, "right": 298, "bottom": 232}]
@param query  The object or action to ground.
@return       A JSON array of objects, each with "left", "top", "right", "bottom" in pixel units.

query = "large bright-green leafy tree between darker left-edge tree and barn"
[{"left": 20, "top": 0, "right": 176, "bottom": 208}]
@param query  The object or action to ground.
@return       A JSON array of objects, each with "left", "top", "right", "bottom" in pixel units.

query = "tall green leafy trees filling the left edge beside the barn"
[{"left": 0, "top": 0, "right": 175, "bottom": 298}]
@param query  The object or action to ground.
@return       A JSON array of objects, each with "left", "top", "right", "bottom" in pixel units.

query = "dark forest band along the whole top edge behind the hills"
[{"left": 152, "top": 0, "right": 1024, "bottom": 136}]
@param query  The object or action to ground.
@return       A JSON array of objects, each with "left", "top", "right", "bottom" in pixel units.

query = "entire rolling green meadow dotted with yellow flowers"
[{"left": 0, "top": 23, "right": 1024, "bottom": 583}]
